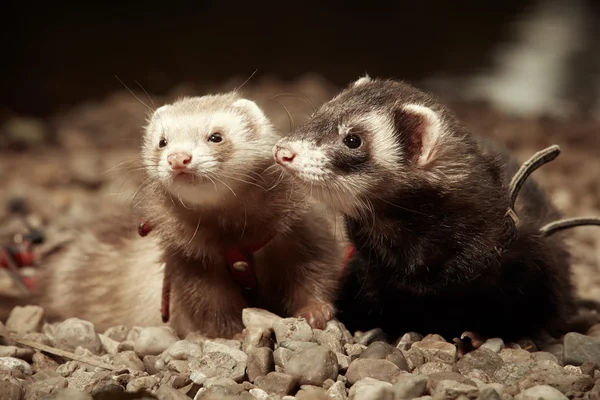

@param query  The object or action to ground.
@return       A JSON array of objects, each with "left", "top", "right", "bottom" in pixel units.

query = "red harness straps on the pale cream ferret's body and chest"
[{"left": 138, "top": 222, "right": 356, "bottom": 323}]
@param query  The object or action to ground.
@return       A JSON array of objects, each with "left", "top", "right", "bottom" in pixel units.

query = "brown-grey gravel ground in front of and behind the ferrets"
[{"left": 0, "top": 76, "right": 600, "bottom": 400}]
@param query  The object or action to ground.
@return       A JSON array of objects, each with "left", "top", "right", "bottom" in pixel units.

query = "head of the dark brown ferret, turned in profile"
[{"left": 273, "top": 76, "right": 460, "bottom": 214}]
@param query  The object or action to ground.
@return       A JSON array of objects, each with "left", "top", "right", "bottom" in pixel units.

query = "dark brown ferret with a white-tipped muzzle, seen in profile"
[{"left": 273, "top": 76, "right": 575, "bottom": 340}]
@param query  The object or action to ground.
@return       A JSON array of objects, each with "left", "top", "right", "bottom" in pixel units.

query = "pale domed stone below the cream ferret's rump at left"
[{"left": 54, "top": 318, "right": 102, "bottom": 354}]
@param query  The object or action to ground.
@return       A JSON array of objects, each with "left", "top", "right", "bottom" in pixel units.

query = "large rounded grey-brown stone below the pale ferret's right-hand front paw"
[{"left": 286, "top": 346, "right": 339, "bottom": 386}]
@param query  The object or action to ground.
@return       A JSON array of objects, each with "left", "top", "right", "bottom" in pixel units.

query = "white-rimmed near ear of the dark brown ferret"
[{"left": 394, "top": 104, "right": 443, "bottom": 168}]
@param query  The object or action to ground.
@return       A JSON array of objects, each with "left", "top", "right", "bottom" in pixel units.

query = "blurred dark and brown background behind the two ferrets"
[{"left": 0, "top": 0, "right": 600, "bottom": 300}]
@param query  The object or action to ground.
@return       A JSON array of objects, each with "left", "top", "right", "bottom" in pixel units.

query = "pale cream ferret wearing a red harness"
[{"left": 28, "top": 92, "right": 346, "bottom": 338}]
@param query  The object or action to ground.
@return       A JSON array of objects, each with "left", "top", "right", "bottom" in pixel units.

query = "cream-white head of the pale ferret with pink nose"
[{"left": 142, "top": 93, "right": 279, "bottom": 206}]
